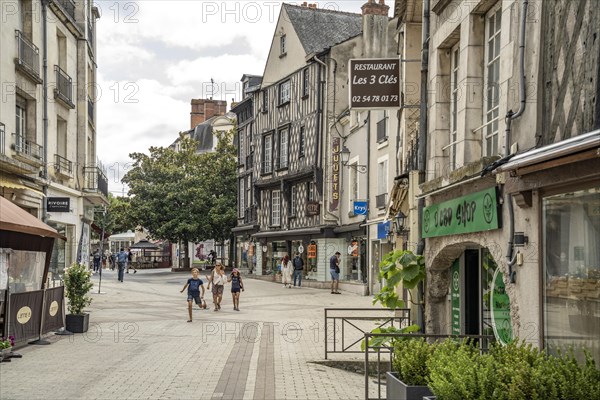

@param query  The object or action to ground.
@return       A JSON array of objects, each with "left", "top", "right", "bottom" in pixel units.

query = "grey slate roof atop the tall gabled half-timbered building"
[{"left": 283, "top": 3, "right": 362, "bottom": 55}]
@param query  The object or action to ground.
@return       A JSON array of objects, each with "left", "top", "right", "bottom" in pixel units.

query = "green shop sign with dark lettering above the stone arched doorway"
[{"left": 422, "top": 187, "right": 500, "bottom": 238}]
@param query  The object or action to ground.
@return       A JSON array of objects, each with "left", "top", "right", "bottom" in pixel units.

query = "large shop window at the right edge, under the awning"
[{"left": 542, "top": 188, "right": 600, "bottom": 363}]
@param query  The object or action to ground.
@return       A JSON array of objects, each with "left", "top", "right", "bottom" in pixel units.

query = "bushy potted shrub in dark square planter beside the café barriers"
[{"left": 65, "top": 263, "right": 93, "bottom": 333}]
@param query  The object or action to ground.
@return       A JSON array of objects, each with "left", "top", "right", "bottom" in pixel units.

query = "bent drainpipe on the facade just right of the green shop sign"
[{"left": 504, "top": 0, "right": 529, "bottom": 283}]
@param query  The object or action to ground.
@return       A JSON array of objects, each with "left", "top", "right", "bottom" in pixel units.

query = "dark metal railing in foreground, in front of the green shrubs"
[{"left": 363, "top": 332, "right": 496, "bottom": 400}]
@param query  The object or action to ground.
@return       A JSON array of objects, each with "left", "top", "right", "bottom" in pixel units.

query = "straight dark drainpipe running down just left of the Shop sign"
[{"left": 417, "top": 0, "right": 430, "bottom": 332}]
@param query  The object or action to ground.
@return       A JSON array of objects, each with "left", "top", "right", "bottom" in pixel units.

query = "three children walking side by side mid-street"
[{"left": 180, "top": 264, "right": 244, "bottom": 322}]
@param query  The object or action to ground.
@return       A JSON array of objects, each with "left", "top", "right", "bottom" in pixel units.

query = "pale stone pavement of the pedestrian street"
[{"left": 0, "top": 270, "right": 384, "bottom": 399}]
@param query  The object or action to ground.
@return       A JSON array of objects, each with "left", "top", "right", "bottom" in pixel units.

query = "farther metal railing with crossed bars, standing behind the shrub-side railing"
[{"left": 325, "top": 308, "right": 410, "bottom": 359}]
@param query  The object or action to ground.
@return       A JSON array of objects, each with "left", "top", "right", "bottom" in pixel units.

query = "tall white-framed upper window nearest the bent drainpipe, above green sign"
[{"left": 483, "top": 2, "right": 502, "bottom": 156}]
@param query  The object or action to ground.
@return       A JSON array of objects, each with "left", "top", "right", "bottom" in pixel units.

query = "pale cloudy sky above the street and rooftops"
[{"left": 94, "top": 0, "right": 366, "bottom": 195}]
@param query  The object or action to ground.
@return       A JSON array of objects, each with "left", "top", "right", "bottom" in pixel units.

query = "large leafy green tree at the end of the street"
[{"left": 123, "top": 131, "right": 237, "bottom": 267}]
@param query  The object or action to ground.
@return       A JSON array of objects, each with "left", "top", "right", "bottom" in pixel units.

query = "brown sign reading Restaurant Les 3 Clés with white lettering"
[{"left": 348, "top": 58, "right": 400, "bottom": 108}]
